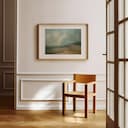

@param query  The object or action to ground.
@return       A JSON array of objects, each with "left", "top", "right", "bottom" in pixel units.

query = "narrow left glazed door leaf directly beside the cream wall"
[{"left": 106, "top": 0, "right": 116, "bottom": 128}]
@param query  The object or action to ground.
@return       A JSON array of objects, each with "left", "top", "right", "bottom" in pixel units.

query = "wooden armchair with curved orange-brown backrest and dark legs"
[{"left": 62, "top": 74, "right": 96, "bottom": 118}]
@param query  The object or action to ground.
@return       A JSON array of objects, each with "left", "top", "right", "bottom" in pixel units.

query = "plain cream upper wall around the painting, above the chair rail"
[{"left": 17, "top": 0, "right": 106, "bottom": 74}]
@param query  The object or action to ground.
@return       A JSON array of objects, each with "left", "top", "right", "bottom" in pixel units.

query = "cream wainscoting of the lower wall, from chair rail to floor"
[{"left": 16, "top": 73, "right": 106, "bottom": 110}]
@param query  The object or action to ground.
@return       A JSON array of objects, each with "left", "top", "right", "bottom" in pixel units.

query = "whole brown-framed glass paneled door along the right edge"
[{"left": 106, "top": 0, "right": 128, "bottom": 128}]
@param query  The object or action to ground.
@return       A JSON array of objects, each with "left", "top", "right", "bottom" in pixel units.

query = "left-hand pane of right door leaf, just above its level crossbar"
[{"left": 118, "top": 24, "right": 124, "bottom": 58}]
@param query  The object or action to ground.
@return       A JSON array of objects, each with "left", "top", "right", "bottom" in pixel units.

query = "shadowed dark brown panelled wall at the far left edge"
[{"left": 0, "top": 0, "right": 16, "bottom": 97}]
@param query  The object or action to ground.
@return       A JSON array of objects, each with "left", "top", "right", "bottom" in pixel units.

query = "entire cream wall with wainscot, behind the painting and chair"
[{"left": 16, "top": 0, "right": 105, "bottom": 109}]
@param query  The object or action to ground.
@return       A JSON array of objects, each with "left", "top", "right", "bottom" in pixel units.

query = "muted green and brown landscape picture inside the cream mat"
[{"left": 45, "top": 28, "right": 81, "bottom": 55}]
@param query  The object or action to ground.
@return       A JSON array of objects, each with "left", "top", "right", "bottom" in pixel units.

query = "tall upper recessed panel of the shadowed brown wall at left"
[{"left": 3, "top": 0, "right": 16, "bottom": 62}]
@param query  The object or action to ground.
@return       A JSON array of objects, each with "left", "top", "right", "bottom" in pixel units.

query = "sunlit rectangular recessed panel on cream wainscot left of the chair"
[{"left": 19, "top": 79, "right": 62, "bottom": 101}]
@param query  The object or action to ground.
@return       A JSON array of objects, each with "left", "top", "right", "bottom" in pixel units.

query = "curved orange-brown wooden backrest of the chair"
[{"left": 73, "top": 74, "right": 96, "bottom": 83}]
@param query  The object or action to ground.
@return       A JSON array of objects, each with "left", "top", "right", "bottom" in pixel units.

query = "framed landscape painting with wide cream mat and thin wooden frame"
[{"left": 38, "top": 24, "right": 88, "bottom": 60}]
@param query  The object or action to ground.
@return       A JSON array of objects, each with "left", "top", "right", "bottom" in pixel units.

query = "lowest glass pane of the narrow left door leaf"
[{"left": 109, "top": 92, "right": 114, "bottom": 120}]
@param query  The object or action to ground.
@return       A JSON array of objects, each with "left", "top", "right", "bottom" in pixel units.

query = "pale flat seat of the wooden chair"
[{"left": 64, "top": 91, "right": 96, "bottom": 98}]
